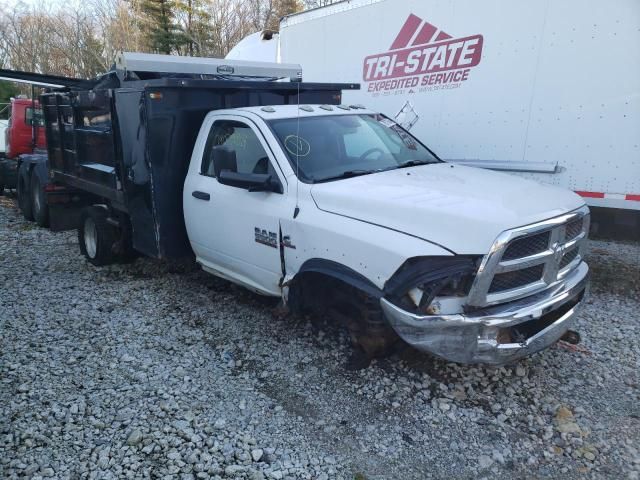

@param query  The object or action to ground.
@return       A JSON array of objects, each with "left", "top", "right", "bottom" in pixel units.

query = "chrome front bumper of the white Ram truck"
[{"left": 380, "top": 262, "right": 589, "bottom": 365}]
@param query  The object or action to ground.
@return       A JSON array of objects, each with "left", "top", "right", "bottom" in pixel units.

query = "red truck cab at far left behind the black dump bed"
[{"left": 5, "top": 98, "right": 46, "bottom": 158}]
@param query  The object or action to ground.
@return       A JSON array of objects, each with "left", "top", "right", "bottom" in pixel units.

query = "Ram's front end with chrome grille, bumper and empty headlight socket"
[{"left": 380, "top": 208, "right": 589, "bottom": 365}]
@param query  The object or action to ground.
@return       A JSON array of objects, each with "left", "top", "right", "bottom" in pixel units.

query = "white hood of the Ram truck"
[{"left": 311, "top": 163, "right": 584, "bottom": 254}]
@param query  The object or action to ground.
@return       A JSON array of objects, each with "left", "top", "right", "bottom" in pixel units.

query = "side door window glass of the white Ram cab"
[{"left": 200, "top": 120, "right": 275, "bottom": 177}]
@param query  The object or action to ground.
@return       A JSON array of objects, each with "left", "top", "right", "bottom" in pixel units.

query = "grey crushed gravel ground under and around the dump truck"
[{"left": 0, "top": 198, "right": 640, "bottom": 479}]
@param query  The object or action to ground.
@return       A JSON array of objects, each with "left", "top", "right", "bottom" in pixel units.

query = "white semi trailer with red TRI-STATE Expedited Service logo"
[{"left": 230, "top": 0, "right": 640, "bottom": 210}]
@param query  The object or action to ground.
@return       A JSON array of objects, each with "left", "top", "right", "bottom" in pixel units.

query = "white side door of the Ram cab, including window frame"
[{"left": 184, "top": 115, "right": 291, "bottom": 295}]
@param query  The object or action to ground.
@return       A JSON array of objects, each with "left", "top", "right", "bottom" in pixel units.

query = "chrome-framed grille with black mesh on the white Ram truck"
[{"left": 467, "top": 206, "right": 589, "bottom": 307}]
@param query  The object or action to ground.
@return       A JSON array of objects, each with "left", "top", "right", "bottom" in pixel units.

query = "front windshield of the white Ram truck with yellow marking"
[{"left": 269, "top": 115, "right": 439, "bottom": 183}]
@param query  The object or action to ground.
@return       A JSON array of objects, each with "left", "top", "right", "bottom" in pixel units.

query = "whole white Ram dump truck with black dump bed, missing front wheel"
[{"left": 0, "top": 54, "right": 589, "bottom": 364}]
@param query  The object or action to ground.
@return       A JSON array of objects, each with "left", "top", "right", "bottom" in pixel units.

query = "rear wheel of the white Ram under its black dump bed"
[{"left": 78, "top": 207, "right": 117, "bottom": 266}]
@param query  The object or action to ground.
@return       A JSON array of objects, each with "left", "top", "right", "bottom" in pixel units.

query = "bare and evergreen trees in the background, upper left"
[{"left": 0, "top": 0, "right": 318, "bottom": 74}]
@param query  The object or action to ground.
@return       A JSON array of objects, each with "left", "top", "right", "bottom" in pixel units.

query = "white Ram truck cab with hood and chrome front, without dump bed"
[{"left": 183, "top": 105, "right": 589, "bottom": 364}]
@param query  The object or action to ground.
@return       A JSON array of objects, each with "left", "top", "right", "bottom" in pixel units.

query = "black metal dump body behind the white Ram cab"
[{"left": 41, "top": 78, "right": 358, "bottom": 258}]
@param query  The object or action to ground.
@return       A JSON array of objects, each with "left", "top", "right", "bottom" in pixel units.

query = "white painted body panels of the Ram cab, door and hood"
[{"left": 183, "top": 105, "right": 584, "bottom": 296}]
